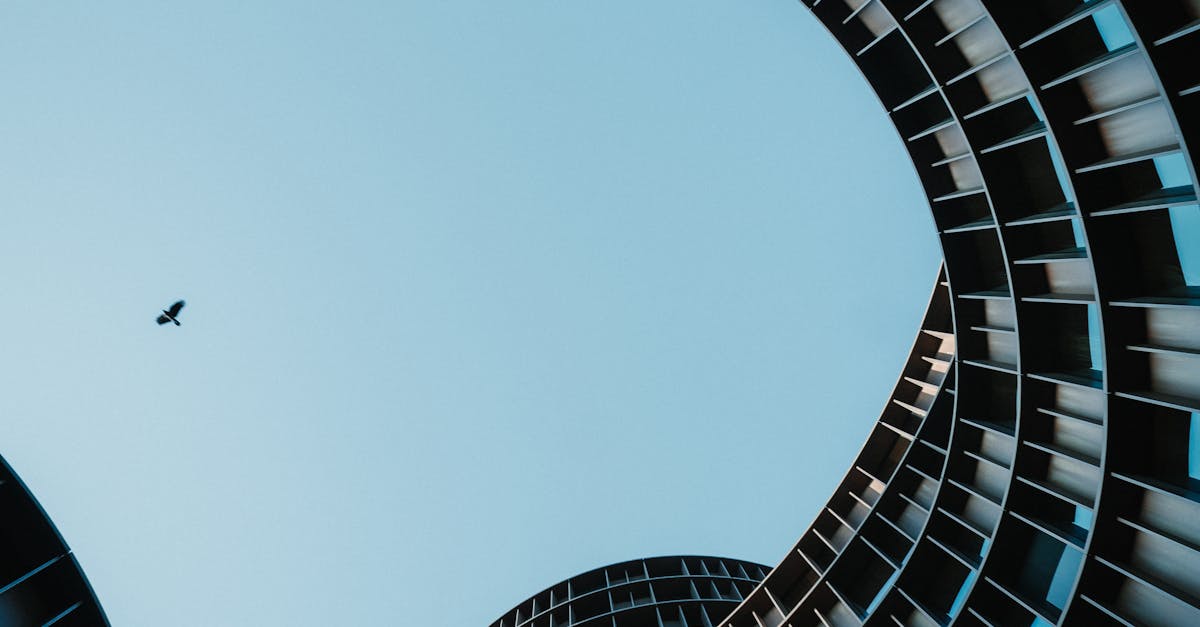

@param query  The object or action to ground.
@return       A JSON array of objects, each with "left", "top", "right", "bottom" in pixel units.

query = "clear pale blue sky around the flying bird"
[{"left": 0, "top": 0, "right": 938, "bottom": 627}]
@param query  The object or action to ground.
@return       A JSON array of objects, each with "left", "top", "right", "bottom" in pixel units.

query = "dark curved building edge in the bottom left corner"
[{"left": 0, "top": 458, "right": 108, "bottom": 627}]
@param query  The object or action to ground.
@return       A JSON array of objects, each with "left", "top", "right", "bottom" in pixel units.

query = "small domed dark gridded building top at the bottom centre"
[{"left": 491, "top": 555, "right": 769, "bottom": 627}]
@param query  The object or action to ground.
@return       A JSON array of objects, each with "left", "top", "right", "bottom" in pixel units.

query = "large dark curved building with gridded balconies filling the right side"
[{"left": 721, "top": 0, "right": 1200, "bottom": 627}]
